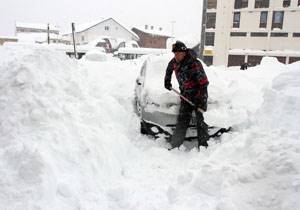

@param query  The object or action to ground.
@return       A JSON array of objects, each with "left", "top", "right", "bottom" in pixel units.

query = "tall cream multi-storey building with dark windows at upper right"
[{"left": 202, "top": 0, "right": 300, "bottom": 66}]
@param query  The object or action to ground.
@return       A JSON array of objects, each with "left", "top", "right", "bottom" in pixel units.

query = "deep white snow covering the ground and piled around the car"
[{"left": 0, "top": 45, "right": 300, "bottom": 210}]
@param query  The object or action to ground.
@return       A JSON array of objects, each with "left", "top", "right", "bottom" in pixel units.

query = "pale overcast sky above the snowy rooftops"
[{"left": 0, "top": 0, "right": 202, "bottom": 36}]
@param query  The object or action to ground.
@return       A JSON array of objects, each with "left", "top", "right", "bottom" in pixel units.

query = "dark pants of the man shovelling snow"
[{"left": 170, "top": 101, "right": 209, "bottom": 148}]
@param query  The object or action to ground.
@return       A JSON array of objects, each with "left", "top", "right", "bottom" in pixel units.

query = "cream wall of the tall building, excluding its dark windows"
[{"left": 207, "top": 0, "right": 300, "bottom": 65}]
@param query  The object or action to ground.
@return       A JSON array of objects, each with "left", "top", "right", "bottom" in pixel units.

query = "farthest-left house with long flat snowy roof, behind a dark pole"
[{"left": 15, "top": 21, "right": 70, "bottom": 44}]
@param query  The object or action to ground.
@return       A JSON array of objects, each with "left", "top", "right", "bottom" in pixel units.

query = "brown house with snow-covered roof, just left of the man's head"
[{"left": 131, "top": 25, "right": 172, "bottom": 48}]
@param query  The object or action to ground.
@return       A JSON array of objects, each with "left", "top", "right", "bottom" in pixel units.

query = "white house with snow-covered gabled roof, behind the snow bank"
[{"left": 64, "top": 18, "right": 139, "bottom": 44}]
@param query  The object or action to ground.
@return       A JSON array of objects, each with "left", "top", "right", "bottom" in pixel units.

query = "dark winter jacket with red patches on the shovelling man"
[{"left": 165, "top": 52, "right": 209, "bottom": 111}]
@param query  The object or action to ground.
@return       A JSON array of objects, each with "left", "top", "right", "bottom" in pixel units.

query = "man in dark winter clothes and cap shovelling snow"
[{"left": 165, "top": 41, "right": 209, "bottom": 149}]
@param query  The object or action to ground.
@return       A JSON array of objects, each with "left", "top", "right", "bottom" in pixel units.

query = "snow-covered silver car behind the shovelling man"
[{"left": 133, "top": 53, "right": 230, "bottom": 140}]
